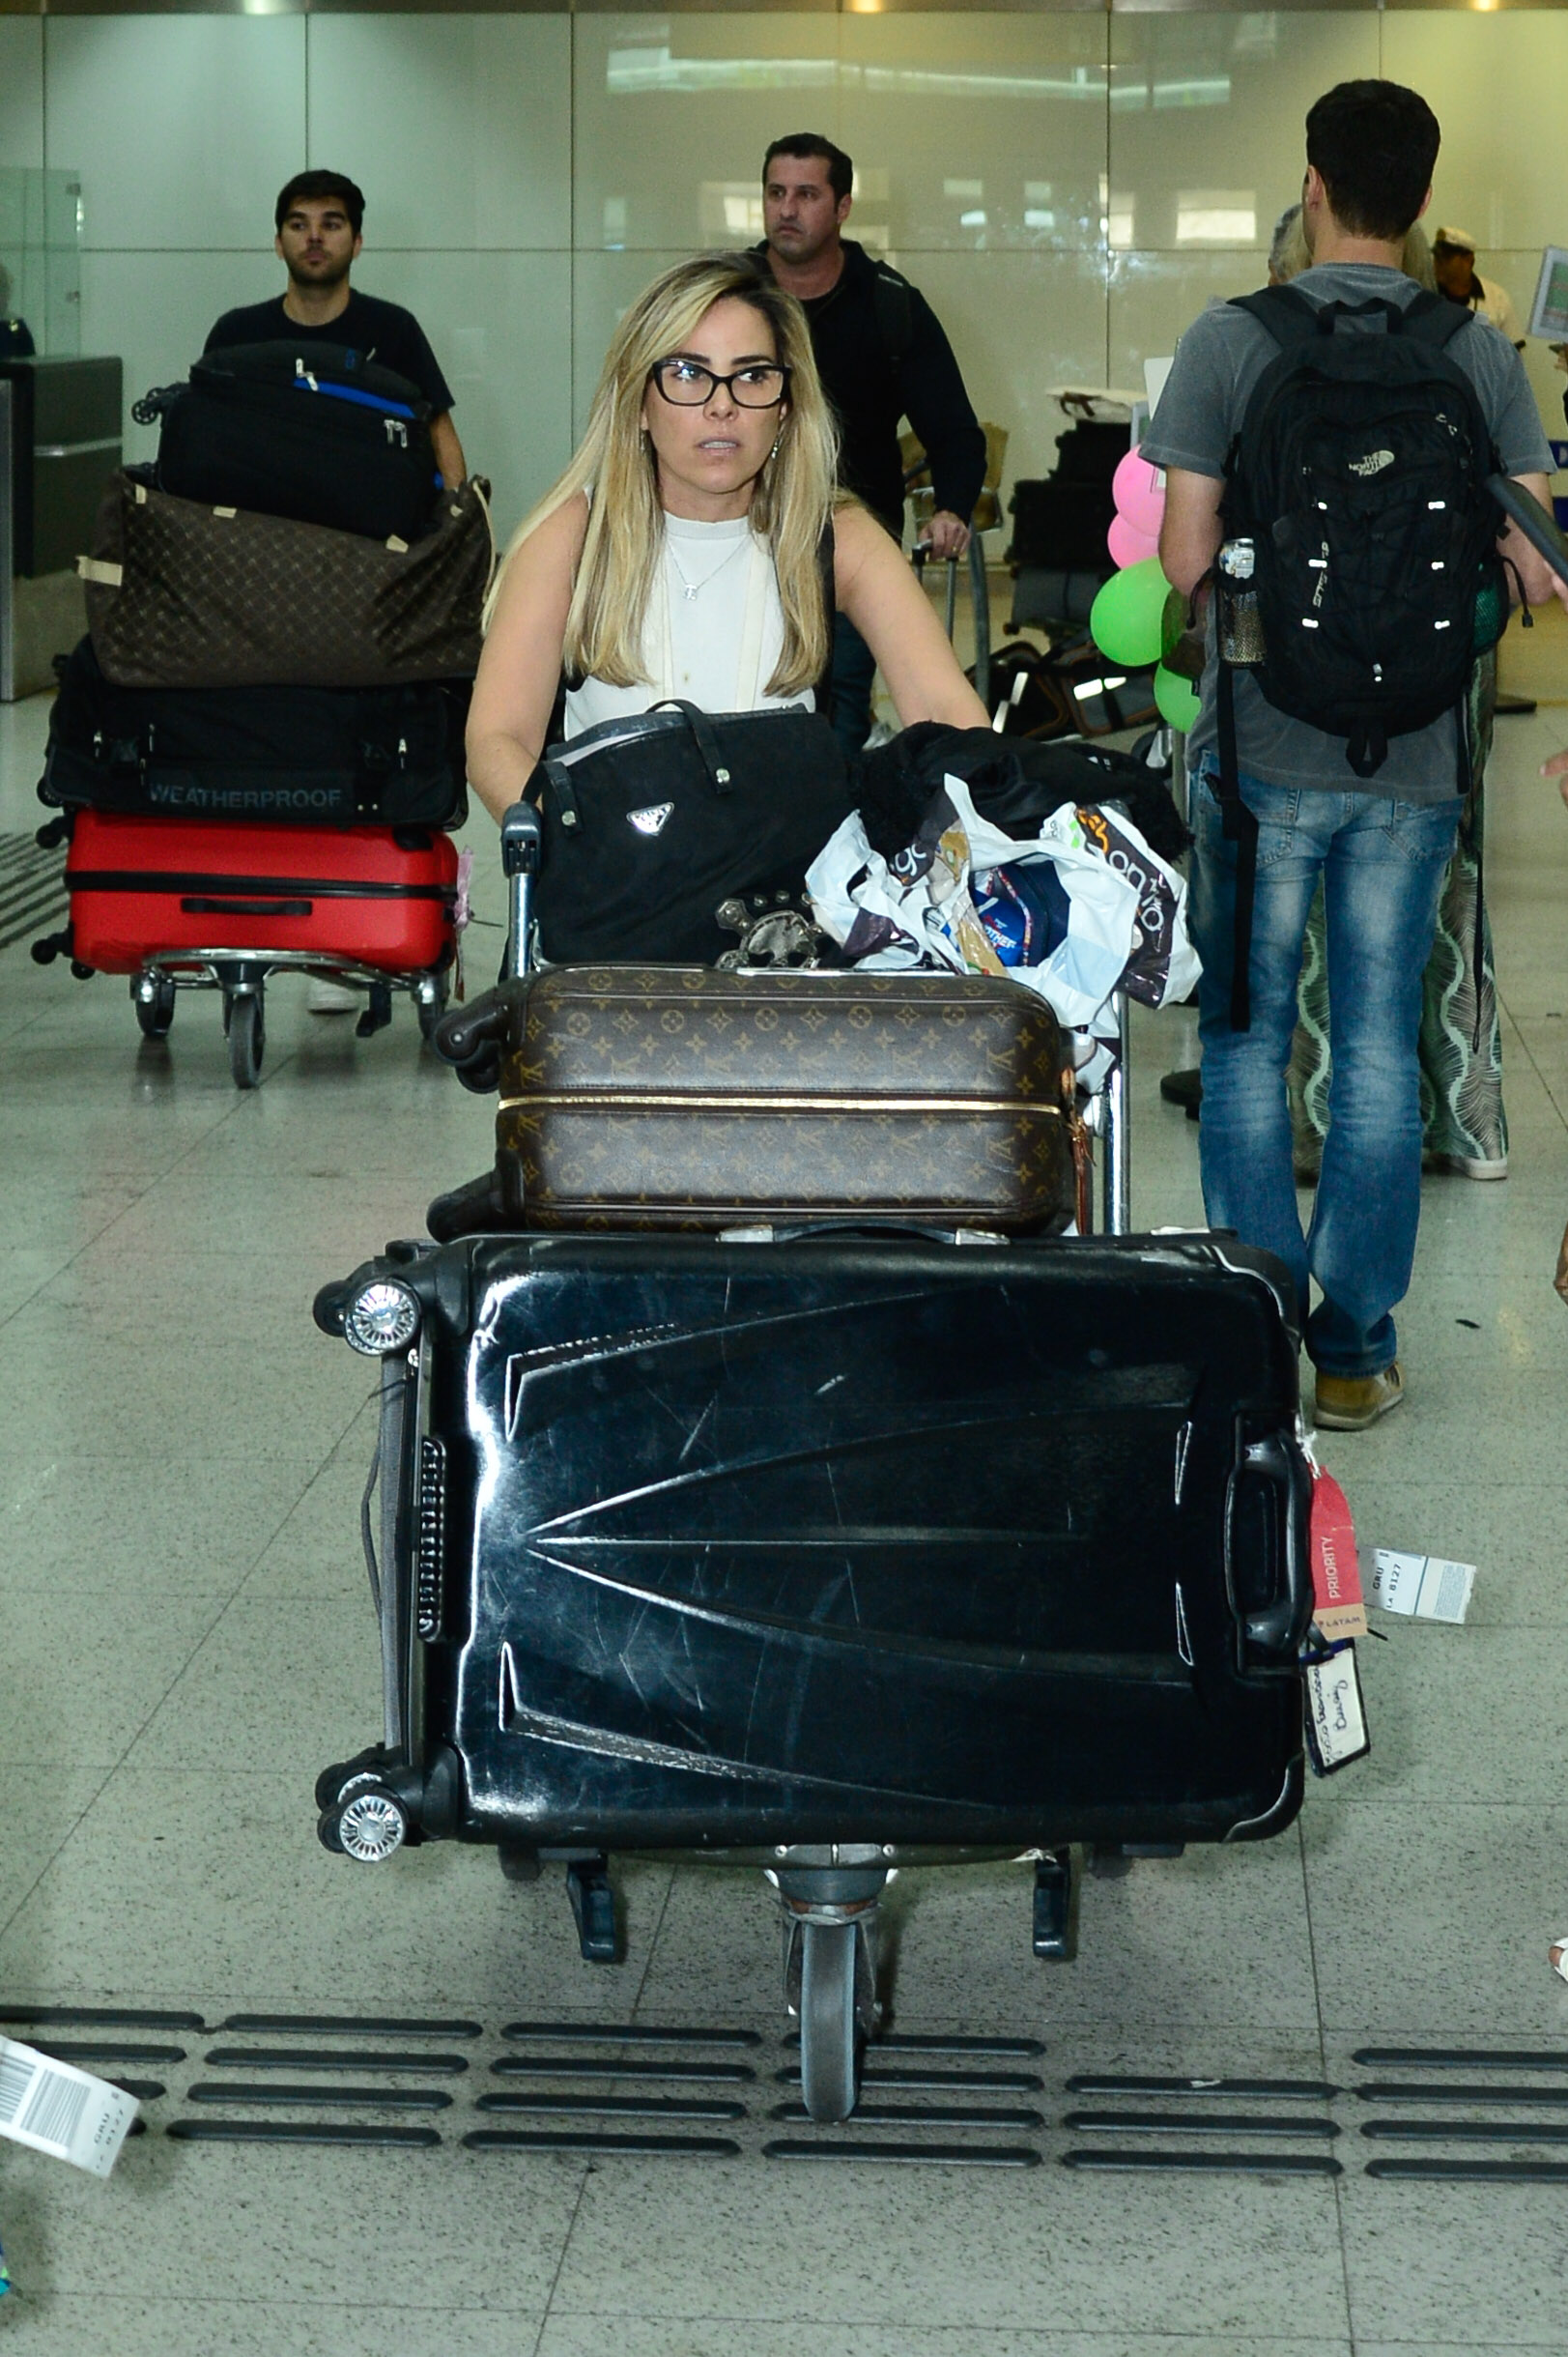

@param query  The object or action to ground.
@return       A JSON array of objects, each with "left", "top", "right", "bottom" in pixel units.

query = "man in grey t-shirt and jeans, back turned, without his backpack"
[{"left": 1141, "top": 80, "right": 1554, "bottom": 1430}]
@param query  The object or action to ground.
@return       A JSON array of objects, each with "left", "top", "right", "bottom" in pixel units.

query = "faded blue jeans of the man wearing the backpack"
[{"left": 1188, "top": 775, "right": 1460, "bottom": 1376}]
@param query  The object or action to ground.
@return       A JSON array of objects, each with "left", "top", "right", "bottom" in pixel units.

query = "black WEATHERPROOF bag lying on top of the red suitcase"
[{"left": 38, "top": 639, "right": 470, "bottom": 827}]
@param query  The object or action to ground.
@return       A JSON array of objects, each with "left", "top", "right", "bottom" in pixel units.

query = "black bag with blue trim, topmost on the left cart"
[{"left": 132, "top": 339, "right": 441, "bottom": 540}]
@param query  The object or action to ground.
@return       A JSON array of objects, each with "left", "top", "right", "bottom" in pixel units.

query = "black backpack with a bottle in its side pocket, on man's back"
[{"left": 1216, "top": 285, "right": 1507, "bottom": 1030}]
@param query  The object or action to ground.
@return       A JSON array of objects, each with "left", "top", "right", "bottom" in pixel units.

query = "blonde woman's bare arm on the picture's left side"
[{"left": 467, "top": 498, "right": 587, "bottom": 825}]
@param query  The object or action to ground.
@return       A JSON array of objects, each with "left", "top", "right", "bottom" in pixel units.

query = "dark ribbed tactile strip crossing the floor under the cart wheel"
[{"left": 0, "top": 2001, "right": 1568, "bottom": 2185}]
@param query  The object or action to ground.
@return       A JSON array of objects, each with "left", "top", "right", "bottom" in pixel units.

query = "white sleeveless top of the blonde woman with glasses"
[{"left": 566, "top": 516, "right": 813, "bottom": 737}]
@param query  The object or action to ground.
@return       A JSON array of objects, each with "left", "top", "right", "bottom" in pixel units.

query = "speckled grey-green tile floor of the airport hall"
[{"left": 0, "top": 674, "right": 1568, "bottom": 2357}]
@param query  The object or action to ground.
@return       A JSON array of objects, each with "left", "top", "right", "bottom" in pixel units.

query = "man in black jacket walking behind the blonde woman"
[{"left": 756, "top": 132, "right": 985, "bottom": 752}]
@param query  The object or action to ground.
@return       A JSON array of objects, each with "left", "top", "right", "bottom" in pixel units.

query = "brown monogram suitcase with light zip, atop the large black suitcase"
[{"left": 485, "top": 966, "right": 1077, "bottom": 1235}]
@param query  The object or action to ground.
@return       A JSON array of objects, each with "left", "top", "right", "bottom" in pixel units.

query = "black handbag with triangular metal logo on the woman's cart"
[{"left": 526, "top": 703, "right": 853, "bottom": 966}]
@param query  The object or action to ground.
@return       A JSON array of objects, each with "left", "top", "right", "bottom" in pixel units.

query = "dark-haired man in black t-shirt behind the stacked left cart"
[{"left": 205, "top": 172, "right": 467, "bottom": 483}]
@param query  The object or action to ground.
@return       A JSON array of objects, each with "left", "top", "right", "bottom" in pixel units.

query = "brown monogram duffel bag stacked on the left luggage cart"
[{"left": 87, "top": 474, "right": 493, "bottom": 688}]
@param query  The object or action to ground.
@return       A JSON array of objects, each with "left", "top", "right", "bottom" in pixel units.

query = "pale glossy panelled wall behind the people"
[{"left": 0, "top": 0, "right": 1568, "bottom": 539}]
